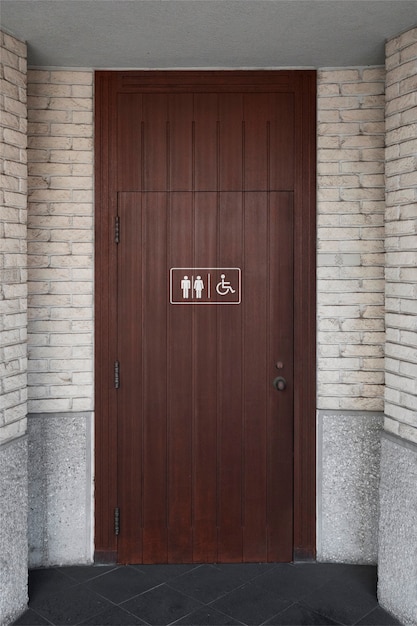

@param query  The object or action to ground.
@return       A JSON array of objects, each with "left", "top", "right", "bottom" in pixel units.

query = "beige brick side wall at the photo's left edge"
[{"left": 0, "top": 32, "right": 27, "bottom": 443}]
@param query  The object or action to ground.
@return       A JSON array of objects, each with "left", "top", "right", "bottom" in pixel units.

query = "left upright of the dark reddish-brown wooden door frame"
[{"left": 94, "top": 72, "right": 118, "bottom": 562}]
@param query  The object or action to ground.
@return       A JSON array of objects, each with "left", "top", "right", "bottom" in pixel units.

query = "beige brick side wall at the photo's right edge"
[{"left": 385, "top": 28, "right": 417, "bottom": 442}]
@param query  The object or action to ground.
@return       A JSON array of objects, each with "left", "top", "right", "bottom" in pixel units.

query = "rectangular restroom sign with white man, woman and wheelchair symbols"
[{"left": 169, "top": 267, "right": 242, "bottom": 304}]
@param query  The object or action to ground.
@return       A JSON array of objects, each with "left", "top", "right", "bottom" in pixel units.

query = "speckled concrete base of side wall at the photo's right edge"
[{"left": 378, "top": 433, "right": 417, "bottom": 626}]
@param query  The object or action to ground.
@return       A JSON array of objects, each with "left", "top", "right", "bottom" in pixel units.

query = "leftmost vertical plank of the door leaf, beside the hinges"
[{"left": 117, "top": 193, "right": 143, "bottom": 563}]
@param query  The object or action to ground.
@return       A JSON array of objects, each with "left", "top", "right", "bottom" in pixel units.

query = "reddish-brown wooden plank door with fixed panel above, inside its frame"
[{"left": 93, "top": 73, "right": 314, "bottom": 563}]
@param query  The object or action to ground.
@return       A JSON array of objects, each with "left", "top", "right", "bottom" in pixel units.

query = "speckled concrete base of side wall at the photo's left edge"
[{"left": 0, "top": 436, "right": 28, "bottom": 624}]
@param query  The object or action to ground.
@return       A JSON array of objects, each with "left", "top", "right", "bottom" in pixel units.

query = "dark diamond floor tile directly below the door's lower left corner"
[{"left": 87, "top": 567, "right": 159, "bottom": 604}]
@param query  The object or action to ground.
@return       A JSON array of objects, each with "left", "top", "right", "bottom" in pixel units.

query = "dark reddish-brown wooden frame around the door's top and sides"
[{"left": 95, "top": 70, "right": 316, "bottom": 563}]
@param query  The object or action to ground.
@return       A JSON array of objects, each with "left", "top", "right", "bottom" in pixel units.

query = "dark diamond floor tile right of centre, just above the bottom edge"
[{"left": 210, "top": 583, "right": 291, "bottom": 626}]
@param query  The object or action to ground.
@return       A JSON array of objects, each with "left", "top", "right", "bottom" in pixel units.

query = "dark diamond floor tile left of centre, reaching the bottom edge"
[{"left": 121, "top": 584, "right": 201, "bottom": 626}]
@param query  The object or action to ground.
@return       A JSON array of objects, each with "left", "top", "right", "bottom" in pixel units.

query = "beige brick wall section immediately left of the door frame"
[{"left": 28, "top": 70, "right": 94, "bottom": 413}]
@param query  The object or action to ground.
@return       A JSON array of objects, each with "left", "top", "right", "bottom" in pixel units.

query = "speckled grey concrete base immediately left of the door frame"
[{"left": 28, "top": 413, "right": 93, "bottom": 568}]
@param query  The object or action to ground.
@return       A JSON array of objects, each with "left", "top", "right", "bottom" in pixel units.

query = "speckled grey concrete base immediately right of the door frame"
[{"left": 317, "top": 410, "right": 383, "bottom": 564}]
